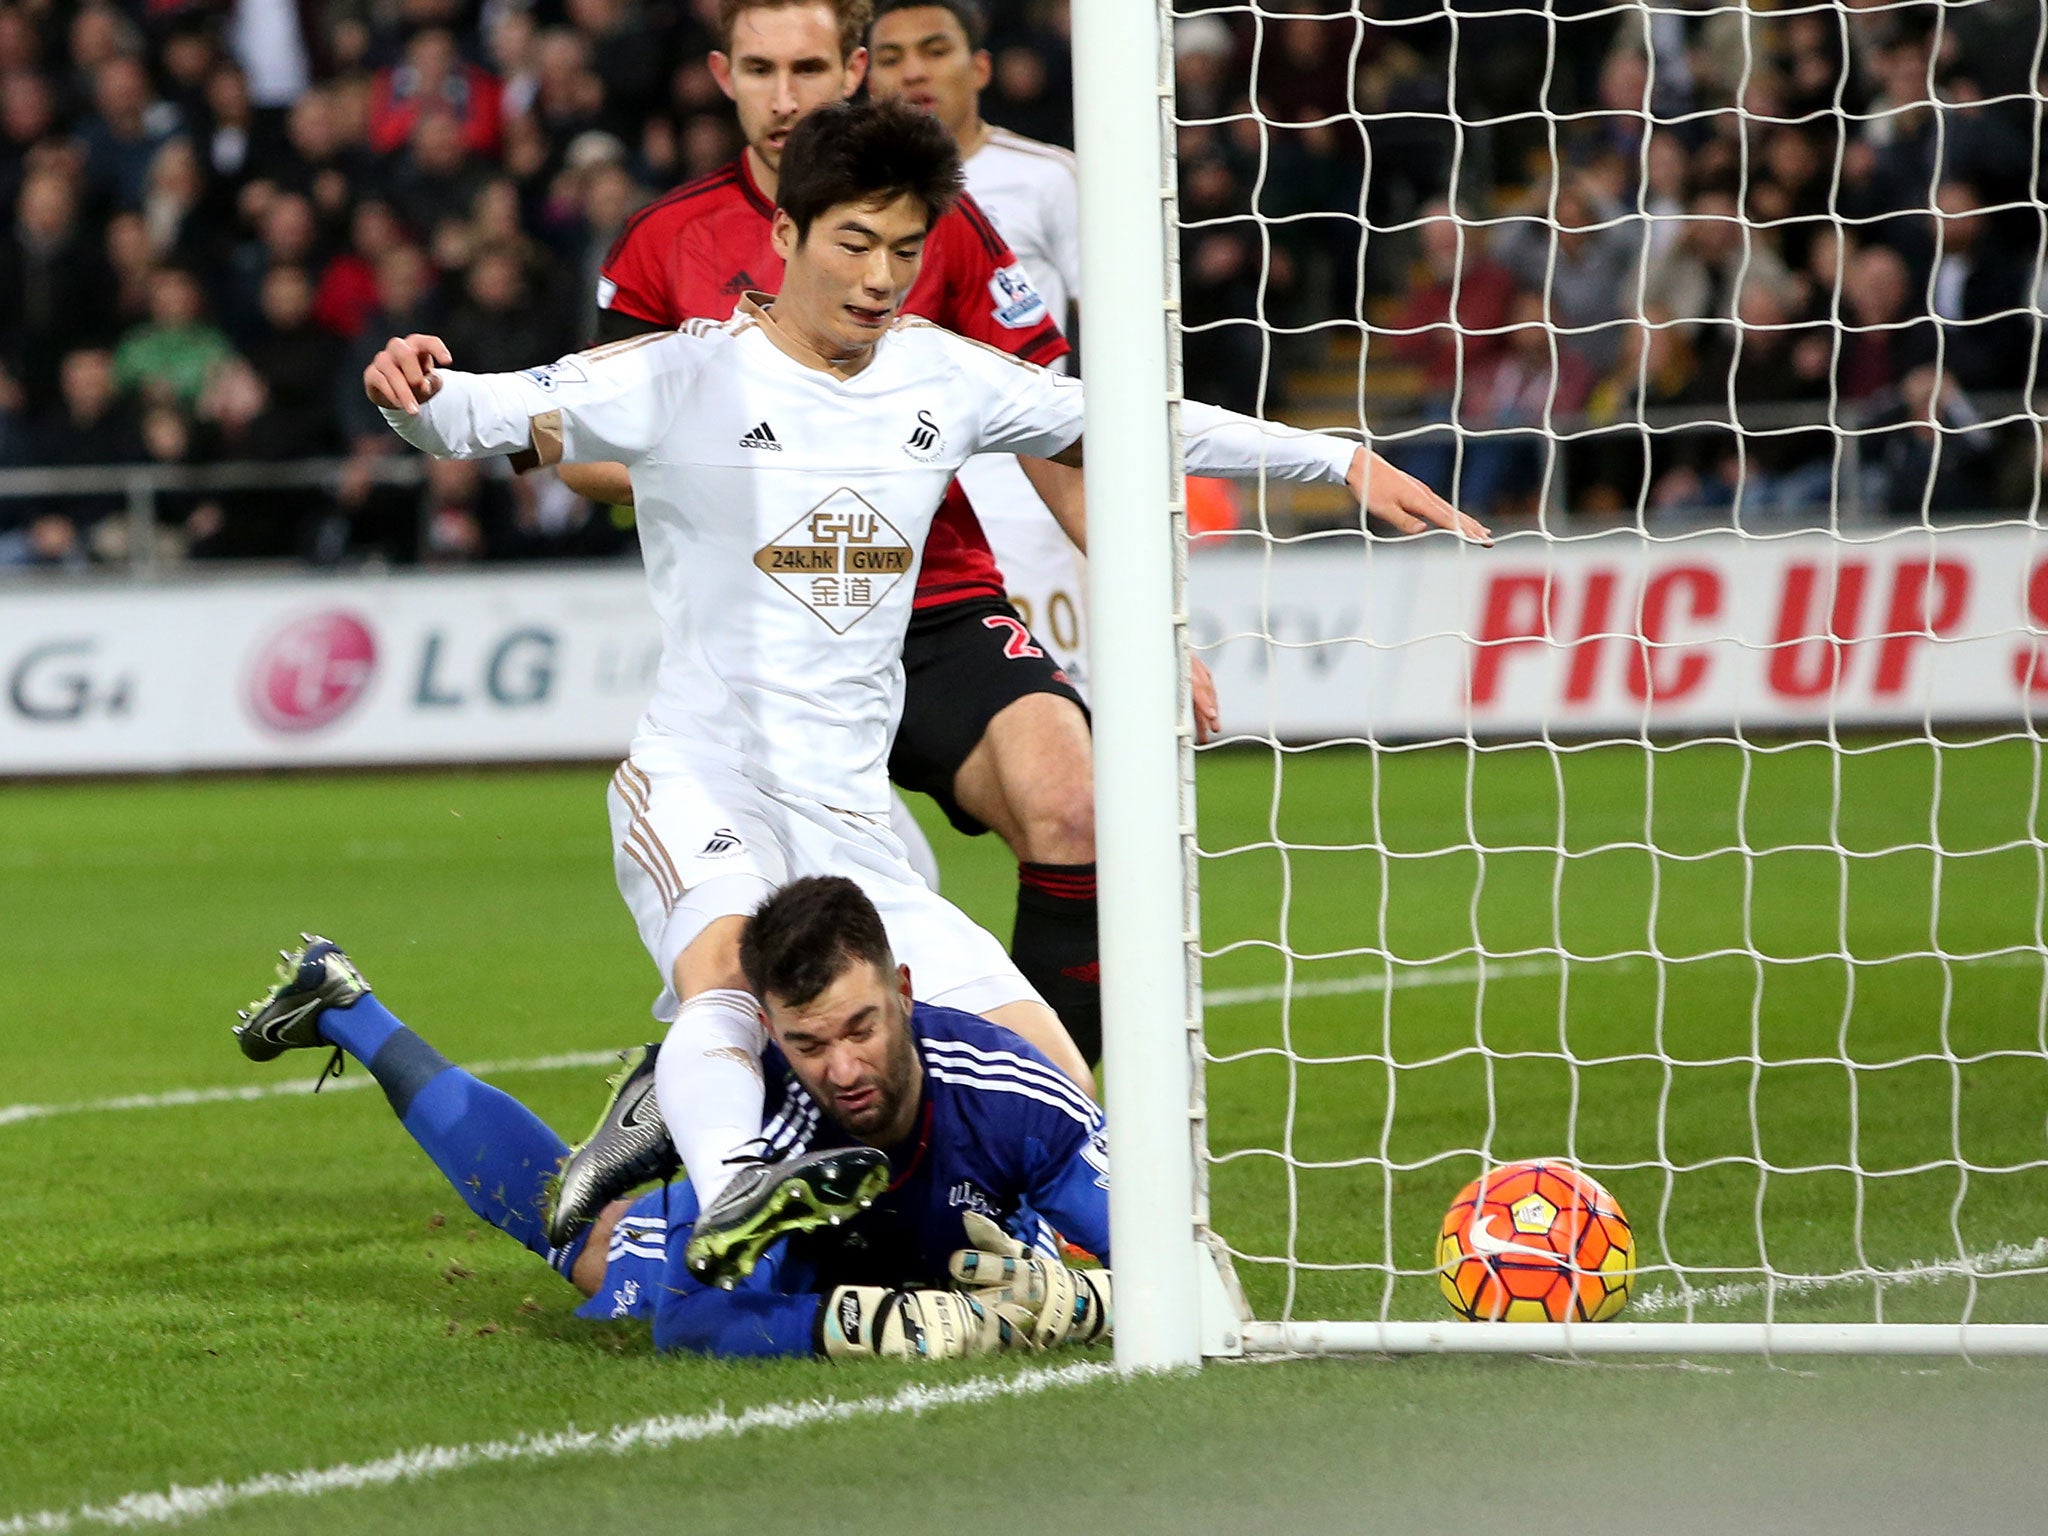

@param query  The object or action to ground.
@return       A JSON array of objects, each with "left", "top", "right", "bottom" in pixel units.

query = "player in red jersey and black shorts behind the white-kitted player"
[{"left": 561, "top": 0, "right": 1102, "bottom": 1063}]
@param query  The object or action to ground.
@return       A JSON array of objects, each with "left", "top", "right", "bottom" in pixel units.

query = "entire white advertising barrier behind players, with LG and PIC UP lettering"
[{"left": 0, "top": 526, "right": 2048, "bottom": 774}]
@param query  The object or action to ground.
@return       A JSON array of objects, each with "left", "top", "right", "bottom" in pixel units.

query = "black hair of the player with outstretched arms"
[{"left": 776, "top": 100, "right": 967, "bottom": 244}]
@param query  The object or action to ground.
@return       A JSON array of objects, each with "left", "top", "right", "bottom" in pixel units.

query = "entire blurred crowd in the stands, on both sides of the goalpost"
[{"left": 0, "top": 0, "right": 2042, "bottom": 565}]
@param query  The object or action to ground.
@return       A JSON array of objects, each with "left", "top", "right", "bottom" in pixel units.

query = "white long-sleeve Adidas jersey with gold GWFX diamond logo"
[{"left": 385, "top": 301, "right": 1356, "bottom": 819}]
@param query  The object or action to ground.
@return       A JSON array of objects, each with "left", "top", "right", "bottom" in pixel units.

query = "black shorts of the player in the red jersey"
[{"left": 889, "top": 598, "right": 1087, "bottom": 838}]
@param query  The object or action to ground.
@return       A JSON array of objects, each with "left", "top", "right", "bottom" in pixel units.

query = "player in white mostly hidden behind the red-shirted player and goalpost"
[{"left": 868, "top": 0, "right": 1087, "bottom": 684}]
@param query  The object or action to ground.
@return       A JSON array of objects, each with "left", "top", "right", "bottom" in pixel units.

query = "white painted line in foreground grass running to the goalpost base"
[{"left": 0, "top": 1362, "right": 1116, "bottom": 1536}]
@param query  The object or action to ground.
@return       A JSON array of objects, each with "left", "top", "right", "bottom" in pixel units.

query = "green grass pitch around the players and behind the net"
[{"left": 0, "top": 741, "right": 2048, "bottom": 1532}]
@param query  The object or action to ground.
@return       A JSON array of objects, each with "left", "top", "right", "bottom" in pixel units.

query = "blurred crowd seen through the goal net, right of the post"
[{"left": 1178, "top": 0, "right": 2048, "bottom": 530}]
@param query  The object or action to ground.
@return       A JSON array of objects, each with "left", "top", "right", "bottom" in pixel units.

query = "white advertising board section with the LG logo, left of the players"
[{"left": 0, "top": 567, "right": 659, "bottom": 772}]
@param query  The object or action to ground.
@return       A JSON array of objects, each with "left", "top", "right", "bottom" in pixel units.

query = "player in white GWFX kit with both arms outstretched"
[{"left": 365, "top": 102, "right": 1487, "bottom": 1276}]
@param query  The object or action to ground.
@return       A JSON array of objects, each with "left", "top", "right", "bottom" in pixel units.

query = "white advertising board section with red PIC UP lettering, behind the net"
[{"left": 1192, "top": 526, "right": 2048, "bottom": 739}]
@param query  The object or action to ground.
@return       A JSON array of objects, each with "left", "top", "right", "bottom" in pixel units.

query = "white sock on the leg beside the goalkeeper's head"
[{"left": 653, "top": 989, "right": 768, "bottom": 1210}]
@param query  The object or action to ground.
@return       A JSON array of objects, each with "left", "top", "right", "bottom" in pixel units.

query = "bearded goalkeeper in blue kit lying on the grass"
[{"left": 236, "top": 877, "right": 1112, "bottom": 1358}]
